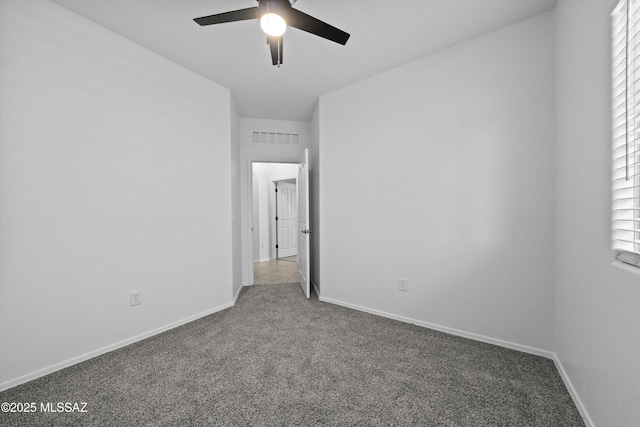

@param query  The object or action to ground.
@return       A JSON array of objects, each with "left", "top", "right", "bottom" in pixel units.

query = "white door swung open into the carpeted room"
[{"left": 298, "top": 149, "right": 311, "bottom": 298}]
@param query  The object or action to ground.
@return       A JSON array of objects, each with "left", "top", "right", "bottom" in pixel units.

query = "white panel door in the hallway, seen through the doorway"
[{"left": 276, "top": 182, "right": 298, "bottom": 258}]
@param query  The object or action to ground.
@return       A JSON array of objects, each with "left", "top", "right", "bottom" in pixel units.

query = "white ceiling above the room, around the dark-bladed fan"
[{"left": 53, "top": 0, "right": 556, "bottom": 121}]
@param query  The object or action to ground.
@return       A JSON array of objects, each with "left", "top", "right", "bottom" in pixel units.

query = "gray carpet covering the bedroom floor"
[{"left": 0, "top": 283, "right": 584, "bottom": 426}]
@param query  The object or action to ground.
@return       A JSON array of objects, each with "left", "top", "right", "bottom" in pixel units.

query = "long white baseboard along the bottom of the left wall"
[{"left": 0, "top": 295, "right": 237, "bottom": 391}]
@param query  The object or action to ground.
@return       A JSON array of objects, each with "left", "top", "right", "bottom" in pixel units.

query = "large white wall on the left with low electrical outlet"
[{"left": 0, "top": 0, "right": 232, "bottom": 388}]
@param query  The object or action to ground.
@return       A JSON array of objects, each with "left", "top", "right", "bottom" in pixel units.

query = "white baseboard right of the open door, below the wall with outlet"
[{"left": 319, "top": 297, "right": 555, "bottom": 359}]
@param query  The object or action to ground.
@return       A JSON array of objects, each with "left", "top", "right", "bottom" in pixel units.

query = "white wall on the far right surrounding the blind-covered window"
[{"left": 554, "top": 0, "right": 640, "bottom": 427}]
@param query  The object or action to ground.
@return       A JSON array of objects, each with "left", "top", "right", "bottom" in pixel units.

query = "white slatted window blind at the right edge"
[{"left": 612, "top": 0, "right": 640, "bottom": 267}]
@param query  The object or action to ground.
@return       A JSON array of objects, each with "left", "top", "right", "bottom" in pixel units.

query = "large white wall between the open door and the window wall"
[{"left": 319, "top": 13, "right": 555, "bottom": 354}]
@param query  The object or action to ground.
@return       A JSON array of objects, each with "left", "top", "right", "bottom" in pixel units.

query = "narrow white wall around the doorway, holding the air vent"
[{"left": 240, "top": 118, "right": 311, "bottom": 285}]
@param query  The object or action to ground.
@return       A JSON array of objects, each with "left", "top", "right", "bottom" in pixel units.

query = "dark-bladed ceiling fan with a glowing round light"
[{"left": 194, "top": 0, "right": 350, "bottom": 67}]
